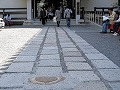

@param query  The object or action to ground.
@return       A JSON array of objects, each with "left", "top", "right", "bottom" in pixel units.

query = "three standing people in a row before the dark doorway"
[{"left": 40, "top": 7, "right": 72, "bottom": 27}]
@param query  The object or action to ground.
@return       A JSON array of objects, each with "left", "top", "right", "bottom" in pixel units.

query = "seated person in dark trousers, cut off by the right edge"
[{"left": 113, "top": 7, "right": 120, "bottom": 36}]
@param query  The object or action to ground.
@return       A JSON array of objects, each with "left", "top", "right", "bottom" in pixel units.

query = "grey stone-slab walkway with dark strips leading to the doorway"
[{"left": 0, "top": 26, "right": 120, "bottom": 90}]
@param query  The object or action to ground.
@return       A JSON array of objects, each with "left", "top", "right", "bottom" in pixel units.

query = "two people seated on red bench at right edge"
[{"left": 101, "top": 7, "right": 120, "bottom": 36}]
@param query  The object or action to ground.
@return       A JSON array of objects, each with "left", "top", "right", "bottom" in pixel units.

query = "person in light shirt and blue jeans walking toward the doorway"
[{"left": 64, "top": 7, "right": 72, "bottom": 27}]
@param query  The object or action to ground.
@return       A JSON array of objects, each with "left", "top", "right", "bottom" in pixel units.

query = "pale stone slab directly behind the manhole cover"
[{"left": 36, "top": 67, "right": 62, "bottom": 76}]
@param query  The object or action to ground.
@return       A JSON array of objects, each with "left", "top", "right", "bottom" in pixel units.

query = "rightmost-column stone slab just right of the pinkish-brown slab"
[{"left": 85, "top": 54, "right": 108, "bottom": 60}]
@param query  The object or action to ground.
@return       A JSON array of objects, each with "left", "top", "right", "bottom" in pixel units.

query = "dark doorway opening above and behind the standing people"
[{"left": 32, "top": 0, "right": 75, "bottom": 18}]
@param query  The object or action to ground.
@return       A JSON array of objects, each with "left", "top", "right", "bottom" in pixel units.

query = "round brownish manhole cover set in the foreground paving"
[{"left": 30, "top": 77, "right": 65, "bottom": 85}]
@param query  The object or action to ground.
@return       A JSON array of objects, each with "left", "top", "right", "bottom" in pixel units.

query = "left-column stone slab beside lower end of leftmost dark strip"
[{"left": 6, "top": 62, "right": 34, "bottom": 73}]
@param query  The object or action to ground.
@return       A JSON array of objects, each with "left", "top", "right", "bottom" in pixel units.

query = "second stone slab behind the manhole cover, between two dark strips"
[{"left": 38, "top": 60, "right": 61, "bottom": 67}]
